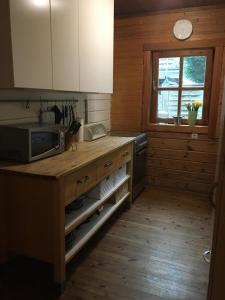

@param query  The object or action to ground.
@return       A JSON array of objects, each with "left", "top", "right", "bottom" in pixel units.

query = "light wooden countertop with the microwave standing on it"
[{"left": 0, "top": 136, "right": 134, "bottom": 179}]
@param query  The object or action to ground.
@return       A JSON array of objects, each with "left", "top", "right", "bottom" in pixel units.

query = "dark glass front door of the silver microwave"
[{"left": 30, "top": 130, "right": 60, "bottom": 161}]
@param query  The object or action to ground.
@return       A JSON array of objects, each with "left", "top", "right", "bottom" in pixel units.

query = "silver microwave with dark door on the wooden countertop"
[{"left": 0, "top": 124, "right": 64, "bottom": 162}]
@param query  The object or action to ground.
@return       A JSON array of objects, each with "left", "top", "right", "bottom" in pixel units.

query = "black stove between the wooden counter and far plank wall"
[{"left": 110, "top": 131, "right": 148, "bottom": 200}]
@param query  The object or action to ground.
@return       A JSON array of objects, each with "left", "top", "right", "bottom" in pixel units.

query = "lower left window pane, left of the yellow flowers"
[{"left": 157, "top": 91, "right": 178, "bottom": 118}]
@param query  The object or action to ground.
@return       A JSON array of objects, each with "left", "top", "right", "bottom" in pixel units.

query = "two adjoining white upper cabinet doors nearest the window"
[{"left": 51, "top": 0, "right": 114, "bottom": 93}]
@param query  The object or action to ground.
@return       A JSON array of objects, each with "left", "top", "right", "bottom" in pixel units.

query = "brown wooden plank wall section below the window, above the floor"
[{"left": 147, "top": 132, "right": 217, "bottom": 193}]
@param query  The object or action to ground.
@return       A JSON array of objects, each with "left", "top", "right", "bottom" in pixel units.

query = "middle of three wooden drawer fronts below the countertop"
[{"left": 97, "top": 151, "right": 119, "bottom": 180}]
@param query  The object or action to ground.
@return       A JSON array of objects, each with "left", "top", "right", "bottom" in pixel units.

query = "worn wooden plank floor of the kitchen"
[{"left": 0, "top": 189, "right": 212, "bottom": 300}]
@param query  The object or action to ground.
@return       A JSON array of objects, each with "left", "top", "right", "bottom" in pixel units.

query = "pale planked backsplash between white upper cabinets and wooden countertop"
[{"left": 0, "top": 89, "right": 111, "bottom": 130}]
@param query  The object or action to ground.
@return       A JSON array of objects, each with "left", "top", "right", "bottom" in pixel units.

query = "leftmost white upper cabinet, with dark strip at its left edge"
[{"left": 0, "top": 0, "right": 52, "bottom": 89}]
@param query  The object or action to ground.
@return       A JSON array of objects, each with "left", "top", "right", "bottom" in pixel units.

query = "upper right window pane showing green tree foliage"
[{"left": 183, "top": 56, "right": 207, "bottom": 87}]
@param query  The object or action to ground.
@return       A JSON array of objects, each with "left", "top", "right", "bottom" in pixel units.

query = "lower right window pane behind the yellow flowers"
[{"left": 181, "top": 90, "right": 204, "bottom": 119}]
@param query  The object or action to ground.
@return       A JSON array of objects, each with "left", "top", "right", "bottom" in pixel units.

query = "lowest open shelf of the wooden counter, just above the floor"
[{"left": 65, "top": 192, "right": 130, "bottom": 263}]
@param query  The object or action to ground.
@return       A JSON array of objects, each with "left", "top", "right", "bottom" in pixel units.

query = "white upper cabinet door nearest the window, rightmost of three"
[{"left": 79, "top": 0, "right": 114, "bottom": 93}]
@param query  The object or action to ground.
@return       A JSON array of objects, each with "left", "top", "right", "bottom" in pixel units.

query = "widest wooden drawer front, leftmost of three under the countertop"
[{"left": 64, "top": 164, "right": 97, "bottom": 205}]
